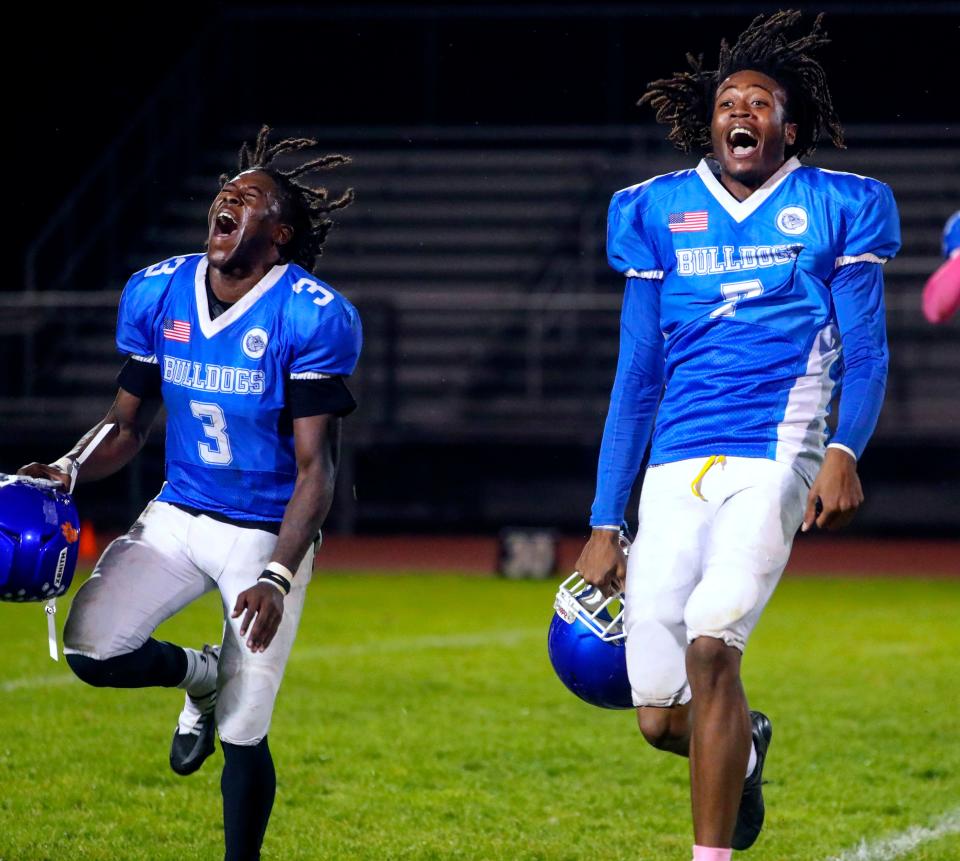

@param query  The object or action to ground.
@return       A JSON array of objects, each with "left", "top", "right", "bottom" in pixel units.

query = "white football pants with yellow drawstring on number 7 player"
[{"left": 624, "top": 457, "right": 808, "bottom": 706}]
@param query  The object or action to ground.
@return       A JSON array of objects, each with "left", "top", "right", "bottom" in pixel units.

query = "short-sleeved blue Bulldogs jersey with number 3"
[{"left": 117, "top": 254, "right": 362, "bottom": 522}]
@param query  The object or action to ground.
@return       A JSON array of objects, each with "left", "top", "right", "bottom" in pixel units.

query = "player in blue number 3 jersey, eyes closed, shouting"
[{"left": 21, "top": 127, "right": 361, "bottom": 861}]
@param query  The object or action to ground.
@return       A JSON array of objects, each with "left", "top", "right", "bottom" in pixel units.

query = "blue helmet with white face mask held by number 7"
[{"left": 547, "top": 572, "right": 633, "bottom": 709}]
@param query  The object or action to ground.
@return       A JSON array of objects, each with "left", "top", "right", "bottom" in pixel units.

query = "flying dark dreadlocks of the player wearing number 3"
[{"left": 220, "top": 125, "right": 353, "bottom": 272}]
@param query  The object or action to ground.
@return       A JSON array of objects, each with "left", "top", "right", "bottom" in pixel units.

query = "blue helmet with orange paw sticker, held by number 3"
[{"left": 0, "top": 473, "right": 80, "bottom": 601}]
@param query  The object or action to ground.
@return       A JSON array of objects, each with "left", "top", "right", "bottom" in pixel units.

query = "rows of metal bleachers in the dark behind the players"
[{"left": 3, "top": 127, "right": 960, "bottom": 450}]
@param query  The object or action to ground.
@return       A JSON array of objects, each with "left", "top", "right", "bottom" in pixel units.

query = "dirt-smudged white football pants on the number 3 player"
[{"left": 63, "top": 501, "right": 315, "bottom": 745}]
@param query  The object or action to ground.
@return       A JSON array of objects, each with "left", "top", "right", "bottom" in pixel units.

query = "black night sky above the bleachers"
[{"left": 13, "top": 2, "right": 960, "bottom": 252}]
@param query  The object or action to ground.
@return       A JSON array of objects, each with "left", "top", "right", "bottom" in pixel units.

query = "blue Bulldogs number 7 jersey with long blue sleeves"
[{"left": 591, "top": 158, "right": 900, "bottom": 525}]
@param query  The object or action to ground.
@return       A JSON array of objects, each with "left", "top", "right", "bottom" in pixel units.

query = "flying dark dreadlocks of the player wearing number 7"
[{"left": 637, "top": 9, "right": 845, "bottom": 158}]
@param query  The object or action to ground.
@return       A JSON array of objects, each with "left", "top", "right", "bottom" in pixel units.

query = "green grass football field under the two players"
[{"left": 0, "top": 573, "right": 960, "bottom": 861}]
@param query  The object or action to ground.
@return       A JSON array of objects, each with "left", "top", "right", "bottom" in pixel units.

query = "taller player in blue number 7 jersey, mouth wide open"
[{"left": 577, "top": 11, "right": 900, "bottom": 861}]
